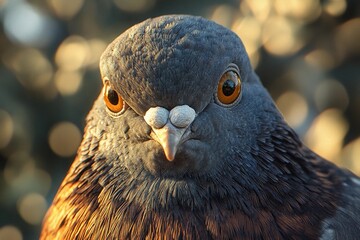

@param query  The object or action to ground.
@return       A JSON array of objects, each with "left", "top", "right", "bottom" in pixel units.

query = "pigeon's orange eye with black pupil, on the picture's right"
[{"left": 217, "top": 70, "right": 241, "bottom": 105}]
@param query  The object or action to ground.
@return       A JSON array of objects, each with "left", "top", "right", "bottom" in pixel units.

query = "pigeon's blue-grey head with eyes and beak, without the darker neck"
[{"left": 95, "top": 16, "right": 274, "bottom": 175}]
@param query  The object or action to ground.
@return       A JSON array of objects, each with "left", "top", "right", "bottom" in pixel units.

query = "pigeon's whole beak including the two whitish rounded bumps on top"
[{"left": 144, "top": 105, "right": 196, "bottom": 161}]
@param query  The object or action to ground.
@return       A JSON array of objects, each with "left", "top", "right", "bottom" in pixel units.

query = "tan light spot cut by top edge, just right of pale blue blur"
[{"left": 47, "top": 0, "right": 84, "bottom": 20}]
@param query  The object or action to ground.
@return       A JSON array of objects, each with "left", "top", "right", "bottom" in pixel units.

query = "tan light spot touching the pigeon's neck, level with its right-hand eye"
[{"left": 276, "top": 91, "right": 308, "bottom": 128}]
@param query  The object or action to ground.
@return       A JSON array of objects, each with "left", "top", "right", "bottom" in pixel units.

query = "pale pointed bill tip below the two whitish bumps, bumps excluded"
[{"left": 153, "top": 122, "right": 186, "bottom": 161}]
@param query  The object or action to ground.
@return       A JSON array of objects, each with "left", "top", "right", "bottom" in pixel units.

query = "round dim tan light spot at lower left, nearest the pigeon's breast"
[{"left": 17, "top": 193, "right": 47, "bottom": 225}]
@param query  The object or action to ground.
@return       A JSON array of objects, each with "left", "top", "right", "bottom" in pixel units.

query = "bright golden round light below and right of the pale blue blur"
[{"left": 55, "top": 36, "right": 90, "bottom": 71}]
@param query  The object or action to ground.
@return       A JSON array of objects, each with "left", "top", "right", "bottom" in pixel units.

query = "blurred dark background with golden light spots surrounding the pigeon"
[{"left": 0, "top": 0, "right": 360, "bottom": 240}]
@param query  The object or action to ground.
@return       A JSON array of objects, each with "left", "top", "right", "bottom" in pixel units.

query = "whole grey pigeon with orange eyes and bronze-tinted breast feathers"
[{"left": 40, "top": 15, "right": 360, "bottom": 239}]
